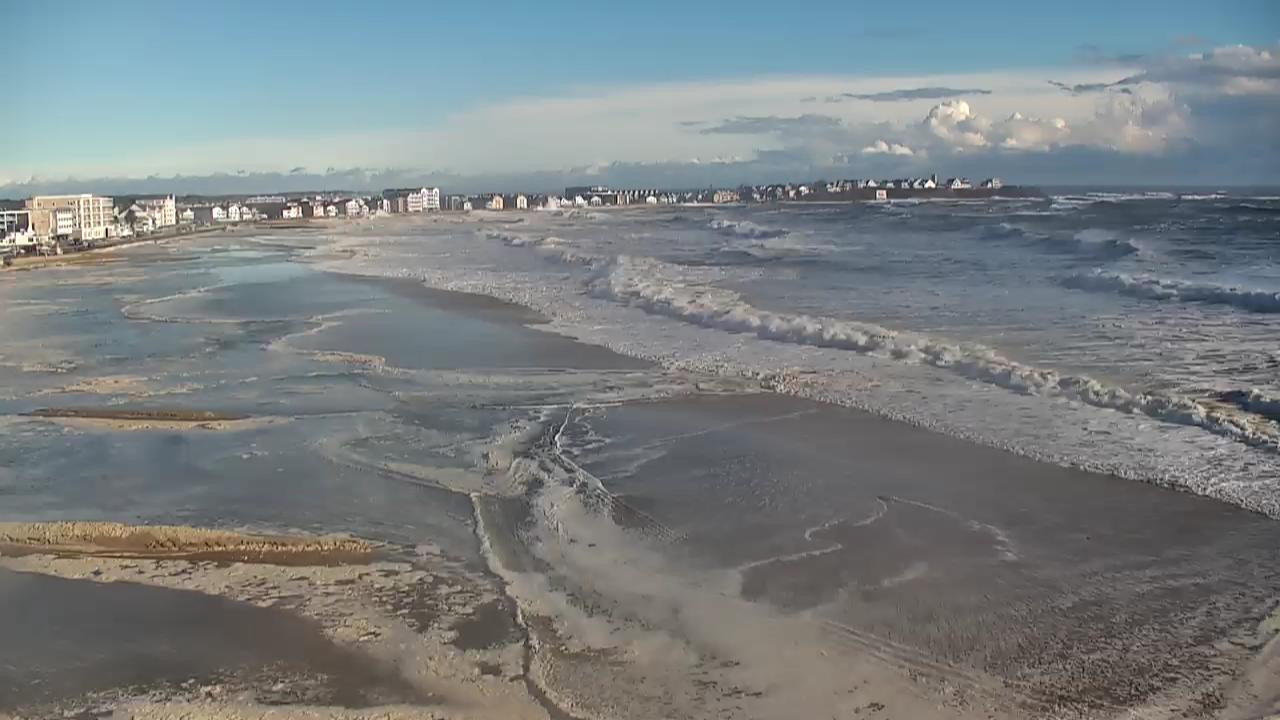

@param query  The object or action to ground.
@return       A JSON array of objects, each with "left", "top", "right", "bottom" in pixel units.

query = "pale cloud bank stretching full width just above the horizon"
[{"left": 0, "top": 46, "right": 1280, "bottom": 197}]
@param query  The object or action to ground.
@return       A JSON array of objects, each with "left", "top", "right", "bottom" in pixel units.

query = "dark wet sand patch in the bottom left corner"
[{"left": 0, "top": 569, "right": 429, "bottom": 715}]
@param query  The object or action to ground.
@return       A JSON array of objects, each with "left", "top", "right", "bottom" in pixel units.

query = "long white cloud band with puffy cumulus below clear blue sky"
[{"left": 0, "top": 46, "right": 1280, "bottom": 185}]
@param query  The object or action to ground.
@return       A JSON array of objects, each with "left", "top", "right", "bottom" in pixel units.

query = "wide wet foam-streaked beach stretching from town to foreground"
[{"left": 0, "top": 214, "right": 1280, "bottom": 719}]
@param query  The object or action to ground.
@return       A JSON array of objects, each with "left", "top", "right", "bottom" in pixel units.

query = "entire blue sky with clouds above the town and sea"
[{"left": 0, "top": 0, "right": 1280, "bottom": 197}]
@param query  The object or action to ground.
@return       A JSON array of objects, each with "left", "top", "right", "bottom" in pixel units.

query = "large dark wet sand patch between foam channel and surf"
[{"left": 570, "top": 395, "right": 1280, "bottom": 716}]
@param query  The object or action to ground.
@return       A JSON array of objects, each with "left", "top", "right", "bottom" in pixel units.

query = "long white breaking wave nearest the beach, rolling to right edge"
[{"left": 590, "top": 255, "right": 1280, "bottom": 450}]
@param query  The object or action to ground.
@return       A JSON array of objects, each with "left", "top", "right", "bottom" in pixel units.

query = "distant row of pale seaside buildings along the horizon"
[{"left": 0, "top": 176, "right": 1018, "bottom": 258}]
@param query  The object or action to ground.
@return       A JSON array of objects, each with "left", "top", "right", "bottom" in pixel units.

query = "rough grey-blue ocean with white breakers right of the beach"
[{"left": 324, "top": 192, "right": 1280, "bottom": 518}]
